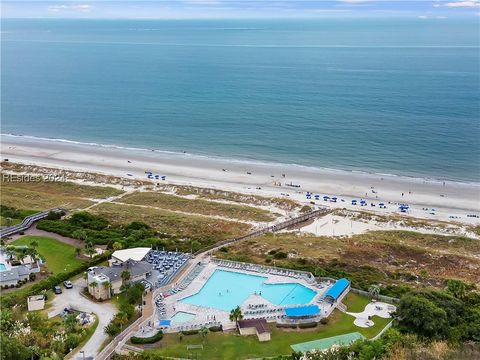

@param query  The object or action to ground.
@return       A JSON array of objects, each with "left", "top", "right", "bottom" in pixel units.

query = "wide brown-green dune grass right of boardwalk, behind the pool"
[{"left": 215, "top": 230, "right": 480, "bottom": 288}]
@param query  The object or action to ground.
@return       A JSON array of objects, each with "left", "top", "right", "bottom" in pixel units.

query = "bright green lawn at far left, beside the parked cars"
[{"left": 12, "top": 236, "right": 83, "bottom": 274}]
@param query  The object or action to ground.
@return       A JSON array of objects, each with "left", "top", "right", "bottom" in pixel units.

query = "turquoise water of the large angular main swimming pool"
[{"left": 181, "top": 270, "right": 316, "bottom": 311}]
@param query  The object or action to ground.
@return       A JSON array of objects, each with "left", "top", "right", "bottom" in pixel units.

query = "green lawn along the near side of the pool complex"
[{"left": 142, "top": 311, "right": 390, "bottom": 359}]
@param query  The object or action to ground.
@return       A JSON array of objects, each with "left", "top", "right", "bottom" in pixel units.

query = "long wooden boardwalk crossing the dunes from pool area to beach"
[{"left": 195, "top": 208, "right": 331, "bottom": 255}]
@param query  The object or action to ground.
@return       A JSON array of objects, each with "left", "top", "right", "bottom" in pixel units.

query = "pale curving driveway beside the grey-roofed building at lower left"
[{"left": 49, "top": 279, "right": 117, "bottom": 359}]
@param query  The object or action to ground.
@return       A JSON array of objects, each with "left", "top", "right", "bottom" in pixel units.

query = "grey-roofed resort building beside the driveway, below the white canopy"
[{"left": 87, "top": 260, "right": 152, "bottom": 300}]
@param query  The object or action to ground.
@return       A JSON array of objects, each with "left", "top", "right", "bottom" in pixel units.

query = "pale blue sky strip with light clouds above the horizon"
[{"left": 1, "top": 0, "right": 480, "bottom": 20}]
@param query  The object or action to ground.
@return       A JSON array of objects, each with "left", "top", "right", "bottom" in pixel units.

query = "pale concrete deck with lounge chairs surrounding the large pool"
[{"left": 155, "top": 261, "right": 333, "bottom": 332}]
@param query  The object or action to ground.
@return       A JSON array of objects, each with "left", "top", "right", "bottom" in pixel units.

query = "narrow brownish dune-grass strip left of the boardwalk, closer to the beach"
[{"left": 119, "top": 192, "right": 275, "bottom": 222}]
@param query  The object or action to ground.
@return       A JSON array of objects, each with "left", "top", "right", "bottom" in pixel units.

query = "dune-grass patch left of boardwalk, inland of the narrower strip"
[{"left": 91, "top": 203, "right": 251, "bottom": 245}]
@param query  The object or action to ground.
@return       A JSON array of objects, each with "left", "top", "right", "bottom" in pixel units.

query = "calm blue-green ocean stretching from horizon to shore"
[{"left": 1, "top": 19, "right": 480, "bottom": 182}]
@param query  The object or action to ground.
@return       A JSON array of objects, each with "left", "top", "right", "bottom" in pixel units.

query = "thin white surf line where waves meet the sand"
[{"left": 0, "top": 133, "right": 480, "bottom": 186}]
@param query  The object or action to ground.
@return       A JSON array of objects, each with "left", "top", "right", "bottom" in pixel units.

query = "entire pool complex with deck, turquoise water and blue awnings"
[{"left": 154, "top": 259, "right": 350, "bottom": 334}]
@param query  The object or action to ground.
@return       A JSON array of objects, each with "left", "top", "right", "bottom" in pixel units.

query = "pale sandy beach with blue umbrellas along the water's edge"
[{"left": 1, "top": 135, "right": 480, "bottom": 224}]
